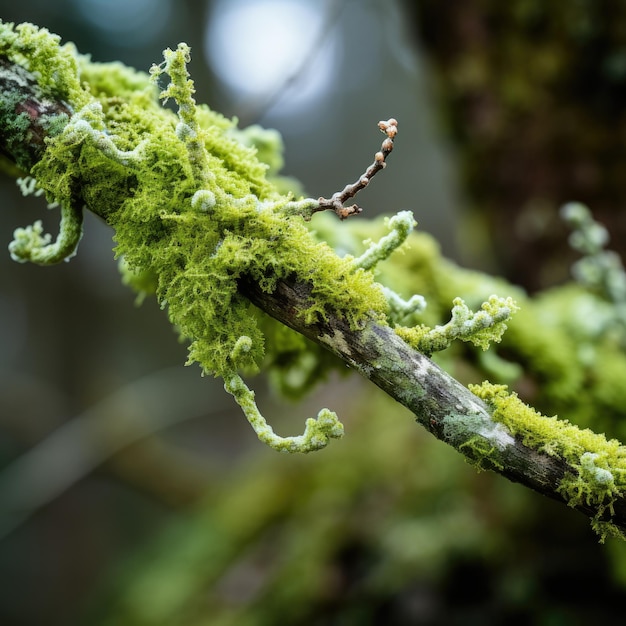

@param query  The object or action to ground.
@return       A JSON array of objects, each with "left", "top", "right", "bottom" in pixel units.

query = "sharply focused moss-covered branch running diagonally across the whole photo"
[{"left": 0, "top": 25, "right": 626, "bottom": 533}]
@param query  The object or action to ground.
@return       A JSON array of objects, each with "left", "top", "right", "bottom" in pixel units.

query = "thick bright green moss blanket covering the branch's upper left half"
[{"left": 0, "top": 24, "right": 387, "bottom": 449}]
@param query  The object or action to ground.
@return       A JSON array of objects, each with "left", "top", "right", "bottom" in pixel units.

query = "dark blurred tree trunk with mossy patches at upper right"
[{"left": 404, "top": 0, "right": 626, "bottom": 290}]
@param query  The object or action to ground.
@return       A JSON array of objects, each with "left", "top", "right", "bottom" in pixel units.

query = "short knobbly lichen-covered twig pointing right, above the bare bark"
[{"left": 395, "top": 295, "right": 518, "bottom": 355}]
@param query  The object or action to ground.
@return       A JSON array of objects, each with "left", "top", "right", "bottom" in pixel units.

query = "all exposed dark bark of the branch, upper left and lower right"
[{"left": 0, "top": 52, "right": 626, "bottom": 531}]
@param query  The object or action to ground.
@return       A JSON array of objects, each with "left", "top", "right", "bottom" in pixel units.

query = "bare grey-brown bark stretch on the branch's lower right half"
[{"left": 242, "top": 282, "right": 626, "bottom": 530}]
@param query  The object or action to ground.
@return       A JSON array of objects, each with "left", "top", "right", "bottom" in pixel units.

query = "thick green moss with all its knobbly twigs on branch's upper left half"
[{"left": 0, "top": 24, "right": 516, "bottom": 451}]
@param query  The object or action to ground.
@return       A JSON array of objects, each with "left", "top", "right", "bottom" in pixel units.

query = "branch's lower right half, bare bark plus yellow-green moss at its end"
[{"left": 242, "top": 281, "right": 626, "bottom": 534}]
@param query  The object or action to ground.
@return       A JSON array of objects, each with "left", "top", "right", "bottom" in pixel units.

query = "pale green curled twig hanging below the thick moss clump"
[{"left": 224, "top": 374, "right": 343, "bottom": 452}]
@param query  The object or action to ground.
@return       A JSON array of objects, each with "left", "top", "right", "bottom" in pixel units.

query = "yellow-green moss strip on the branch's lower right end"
[{"left": 469, "top": 382, "right": 626, "bottom": 538}]
